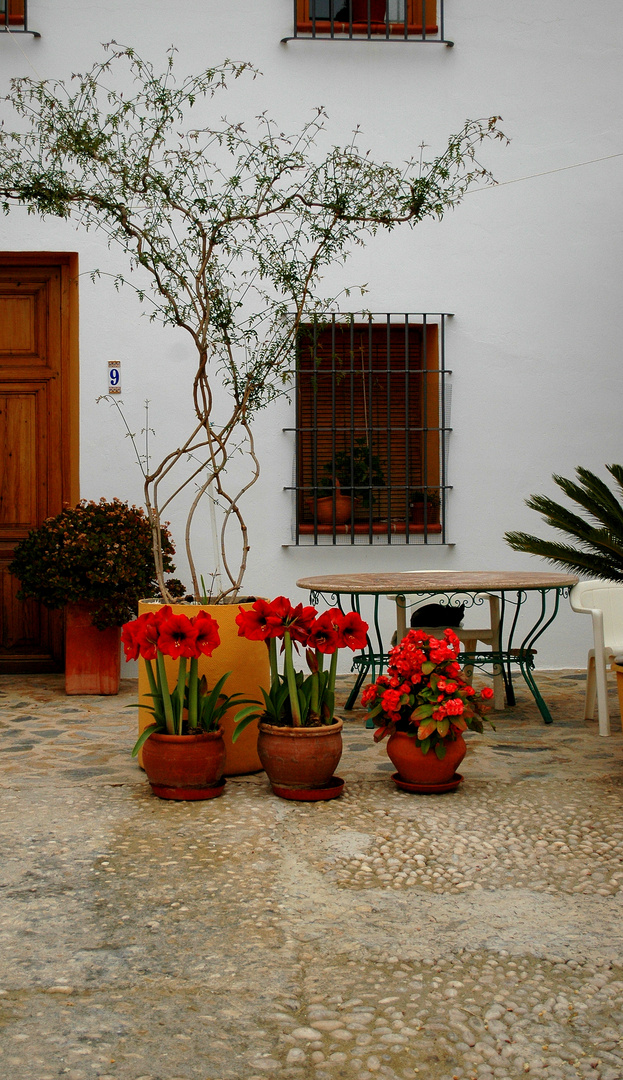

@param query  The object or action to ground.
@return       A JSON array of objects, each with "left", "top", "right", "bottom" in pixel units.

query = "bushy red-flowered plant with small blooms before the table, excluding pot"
[{"left": 362, "top": 630, "right": 493, "bottom": 759}]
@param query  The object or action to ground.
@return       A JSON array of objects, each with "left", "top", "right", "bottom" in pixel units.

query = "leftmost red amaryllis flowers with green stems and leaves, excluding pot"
[{"left": 121, "top": 605, "right": 249, "bottom": 757}]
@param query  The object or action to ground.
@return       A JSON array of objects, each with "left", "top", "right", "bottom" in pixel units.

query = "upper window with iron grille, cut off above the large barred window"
[{"left": 282, "top": 0, "right": 453, "bottom": 46}]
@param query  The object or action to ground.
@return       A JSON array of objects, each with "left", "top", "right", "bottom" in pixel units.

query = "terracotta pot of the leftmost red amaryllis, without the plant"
[{"left": 143, "top": 728, "right": 225, "bottom": 799}]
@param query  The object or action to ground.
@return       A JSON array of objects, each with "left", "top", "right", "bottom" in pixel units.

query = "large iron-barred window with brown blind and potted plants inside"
[{"left": 292, "top": 314, "right": 450, "bottom": 544}]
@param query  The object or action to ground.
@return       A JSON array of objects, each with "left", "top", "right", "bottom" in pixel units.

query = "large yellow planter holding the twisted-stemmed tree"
[{"left": 138, "top": 600, "right": 270, "bottom": 777}]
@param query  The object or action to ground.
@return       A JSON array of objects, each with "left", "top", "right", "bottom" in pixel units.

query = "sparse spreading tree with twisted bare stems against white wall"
[{"left": 0, "top": 43, "right": 504, "bottom": 602}]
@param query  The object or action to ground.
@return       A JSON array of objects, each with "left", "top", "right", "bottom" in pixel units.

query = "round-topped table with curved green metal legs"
[{"left": 297, "top": 570, "right": 578, "bottom": 724}]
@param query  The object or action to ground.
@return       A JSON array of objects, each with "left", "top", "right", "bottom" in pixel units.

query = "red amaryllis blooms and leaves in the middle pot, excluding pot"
[{"left": 233, "top": 596, "right": 368, "bottom": 742}]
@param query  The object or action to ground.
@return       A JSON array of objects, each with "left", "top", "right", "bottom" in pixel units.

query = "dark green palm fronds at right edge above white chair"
[{"left": 504, "top": 465, "right": 623, "bottom": 581}]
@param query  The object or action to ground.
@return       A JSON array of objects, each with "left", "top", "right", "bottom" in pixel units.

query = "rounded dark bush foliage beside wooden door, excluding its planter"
[{"left": 9, "top": 499, "right": 178, "bottom": 630}]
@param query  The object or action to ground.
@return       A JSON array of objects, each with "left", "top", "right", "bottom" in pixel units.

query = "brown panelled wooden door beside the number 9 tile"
[{"left": 0, "top": 254, "right": 78, "bottom": 673}]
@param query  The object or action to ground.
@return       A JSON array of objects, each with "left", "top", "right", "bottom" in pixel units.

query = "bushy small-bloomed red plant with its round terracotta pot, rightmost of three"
[{"left": 362, "top": 627, "right": 493, "bottom": 794}]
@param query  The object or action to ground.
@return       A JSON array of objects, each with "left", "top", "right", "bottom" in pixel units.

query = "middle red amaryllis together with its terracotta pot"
[{"left": 233, "top": 596, "right": 368, "bottom": 801}]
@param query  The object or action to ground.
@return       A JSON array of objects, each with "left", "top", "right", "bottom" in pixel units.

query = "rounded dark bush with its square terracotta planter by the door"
[{"left": 9, "top": 499, "right": 177, "bottom": 694}]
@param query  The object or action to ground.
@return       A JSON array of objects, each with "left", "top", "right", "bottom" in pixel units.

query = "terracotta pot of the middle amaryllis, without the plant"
[{"left": 257, "top": 720, "right": 343, "bottom": 799}]
